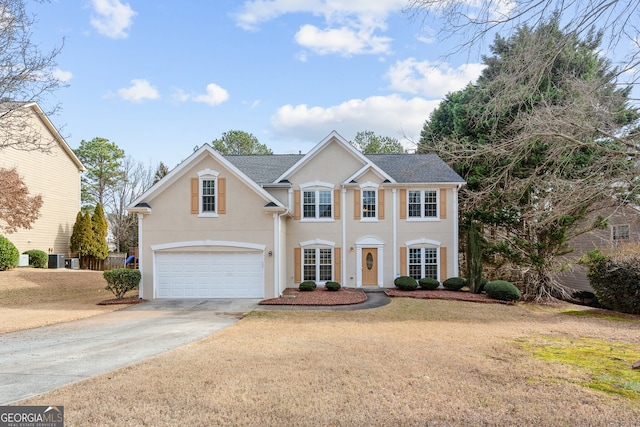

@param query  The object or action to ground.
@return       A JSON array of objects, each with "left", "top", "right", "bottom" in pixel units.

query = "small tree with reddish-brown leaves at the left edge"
[{"left": 0, "top": 168, "right": 42, "bottom": 234}]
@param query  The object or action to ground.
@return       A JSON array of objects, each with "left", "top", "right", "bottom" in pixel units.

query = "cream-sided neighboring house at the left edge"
[{"left": 0, "top": 103, "right": 85, "bottom": 257}]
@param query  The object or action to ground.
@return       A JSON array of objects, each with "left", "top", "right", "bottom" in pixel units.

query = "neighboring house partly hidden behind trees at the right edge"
[{"left": 558, "top": 205, "right": 640, "bottom": 292}]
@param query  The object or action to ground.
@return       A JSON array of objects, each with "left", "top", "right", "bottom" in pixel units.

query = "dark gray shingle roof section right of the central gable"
[{"left": 366, "top": 153, "right": 465, "bottom": 184}]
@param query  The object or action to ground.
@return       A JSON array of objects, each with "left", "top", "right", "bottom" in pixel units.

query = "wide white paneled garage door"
[{"left": 155, "top": 252, "right": 264, "bottom": 298}]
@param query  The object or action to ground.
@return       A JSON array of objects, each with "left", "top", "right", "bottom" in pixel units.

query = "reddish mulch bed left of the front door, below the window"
[{"left": 260, "top": 287, "right": 367, "bottom": 305}]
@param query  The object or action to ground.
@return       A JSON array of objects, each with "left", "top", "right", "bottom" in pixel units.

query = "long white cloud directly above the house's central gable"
[{"left": 271, "top": 95, "right": 440, "bottom": 148}]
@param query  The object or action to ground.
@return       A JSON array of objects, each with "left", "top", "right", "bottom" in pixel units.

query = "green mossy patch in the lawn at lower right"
[{"left": 516, "top": 337, "right": 640, "bottom": 401}]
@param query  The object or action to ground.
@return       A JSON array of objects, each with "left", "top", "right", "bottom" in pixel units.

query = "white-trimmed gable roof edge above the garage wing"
[{"left": 126, "top": 144, "right": 284, "bottom": 212}]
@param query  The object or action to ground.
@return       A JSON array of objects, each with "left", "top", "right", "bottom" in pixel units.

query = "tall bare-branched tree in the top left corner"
[{"left": 0, "top": 0, "right": 63, "bottom": 151}]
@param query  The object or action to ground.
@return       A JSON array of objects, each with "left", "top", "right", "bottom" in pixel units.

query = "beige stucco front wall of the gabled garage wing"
[{"left": 141, "top": 157, "right": 276, "bottom": 298}]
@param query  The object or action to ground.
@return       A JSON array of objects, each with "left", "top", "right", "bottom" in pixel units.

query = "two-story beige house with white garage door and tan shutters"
[{"left": 127, "top": 132, "right": 464, "bottom": 299}]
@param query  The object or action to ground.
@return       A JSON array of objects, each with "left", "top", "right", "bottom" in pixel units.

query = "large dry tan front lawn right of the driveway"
[{"left": 13, "top": 286, "right": 640, "bottom": 426}]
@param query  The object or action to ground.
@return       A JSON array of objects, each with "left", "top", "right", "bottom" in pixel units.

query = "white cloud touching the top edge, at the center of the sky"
[{"left": 235, "top": 0, "right": 405, "bottom": 60}]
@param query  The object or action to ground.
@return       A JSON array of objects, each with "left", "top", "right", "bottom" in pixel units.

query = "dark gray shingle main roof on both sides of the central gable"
[{"left": 224, "top": 154, "right": 464, "bottom": 185}]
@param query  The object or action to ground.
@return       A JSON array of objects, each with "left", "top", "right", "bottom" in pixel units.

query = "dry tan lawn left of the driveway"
[{"left": 0, "top": 268, "right": 137, "bottom": 333}]
